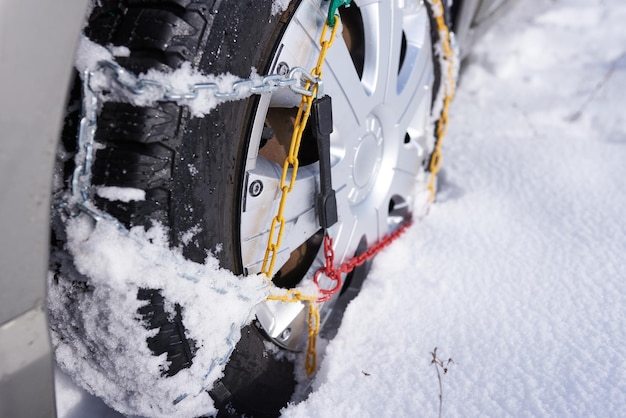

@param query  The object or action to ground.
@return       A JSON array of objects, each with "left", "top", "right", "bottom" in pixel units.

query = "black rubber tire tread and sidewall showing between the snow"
[{"left": 53, "top": 0, "right": 294, "bottom": 416}]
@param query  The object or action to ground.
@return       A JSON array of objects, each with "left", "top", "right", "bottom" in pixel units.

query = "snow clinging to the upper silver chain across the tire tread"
[{"left": 75, "top": 35, "right": 261, "bottom": 117}]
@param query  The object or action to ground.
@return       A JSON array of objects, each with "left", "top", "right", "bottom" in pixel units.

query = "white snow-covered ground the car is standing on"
[{"left": 58, "top": 0, "right": 626, "bottom": 417}]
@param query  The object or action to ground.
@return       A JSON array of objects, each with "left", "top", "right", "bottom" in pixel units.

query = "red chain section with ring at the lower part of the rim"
[{"left": 313, "top": 219, "right": 413, "bottom": 303}]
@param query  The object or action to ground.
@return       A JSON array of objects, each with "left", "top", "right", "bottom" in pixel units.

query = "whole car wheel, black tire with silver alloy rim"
[{"left": 50, "top": 0, "right": 439, "bottom": 416}]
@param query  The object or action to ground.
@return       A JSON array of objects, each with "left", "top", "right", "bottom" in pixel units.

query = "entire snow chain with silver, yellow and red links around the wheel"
[{"left": 70, "top": 0, "right": 455, "bottom": 375}]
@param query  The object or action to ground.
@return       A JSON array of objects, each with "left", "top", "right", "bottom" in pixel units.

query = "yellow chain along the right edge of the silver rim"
[{"left": 427, "top": 0, "right": 456, "bottom": 201}]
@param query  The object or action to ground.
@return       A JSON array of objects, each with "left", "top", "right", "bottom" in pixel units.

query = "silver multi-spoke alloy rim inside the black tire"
[{"left": 236, "top": 0, "right": 434, "bottom": 350}]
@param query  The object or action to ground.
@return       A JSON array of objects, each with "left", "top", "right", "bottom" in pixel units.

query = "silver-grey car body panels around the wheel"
[{"left": 0, "top": 0, "right": 512, "bottom": 417}]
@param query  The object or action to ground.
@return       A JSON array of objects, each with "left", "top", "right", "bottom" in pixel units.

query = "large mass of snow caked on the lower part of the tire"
[{"left": 48, "top": 215, "right": 268, "bottom": 417}]
